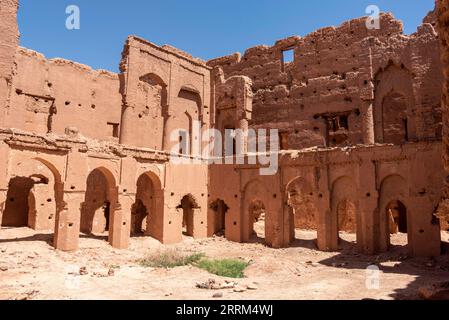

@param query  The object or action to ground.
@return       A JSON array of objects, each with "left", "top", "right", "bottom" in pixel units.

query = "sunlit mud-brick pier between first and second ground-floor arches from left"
[{"left": 54, "top": 191, "right": 84, "bottom": 252}]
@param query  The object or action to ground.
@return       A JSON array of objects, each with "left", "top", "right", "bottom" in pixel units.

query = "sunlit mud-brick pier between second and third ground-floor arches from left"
[{"left": 109, "top": 188, "right": 133, "bottom": 249}]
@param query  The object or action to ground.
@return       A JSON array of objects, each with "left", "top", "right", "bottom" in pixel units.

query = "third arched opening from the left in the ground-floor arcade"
[{"left": 131, "top": 172, "right": 164, "bottom": 241}]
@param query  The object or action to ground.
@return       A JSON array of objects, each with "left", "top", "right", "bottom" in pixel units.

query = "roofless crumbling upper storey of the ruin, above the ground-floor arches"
[{"left": 0, "top": 0, "right": 443, "bottom": 153}]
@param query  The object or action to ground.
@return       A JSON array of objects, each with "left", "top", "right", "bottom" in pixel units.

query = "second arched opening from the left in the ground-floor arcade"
[{"left": 80, "top": 168, "right": 117, "bottom": 237}]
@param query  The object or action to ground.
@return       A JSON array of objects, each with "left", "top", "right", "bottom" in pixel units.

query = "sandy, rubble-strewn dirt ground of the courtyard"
[{"left": 0, "top": 222, "right": 449, "bottom": 300}]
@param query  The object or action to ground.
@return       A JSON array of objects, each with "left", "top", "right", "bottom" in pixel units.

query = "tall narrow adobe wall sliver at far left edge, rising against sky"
[{"left": 0, "top": 0, "right": 19, "bottom": 125}]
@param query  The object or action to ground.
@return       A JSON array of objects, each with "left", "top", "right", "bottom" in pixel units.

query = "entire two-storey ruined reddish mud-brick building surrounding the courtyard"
[{"left": 0, "top": 0, "right": 449, "bottom": 256}]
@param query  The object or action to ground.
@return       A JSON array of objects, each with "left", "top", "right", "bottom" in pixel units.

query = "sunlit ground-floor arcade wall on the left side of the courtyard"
[{"left": 0, "top": 129, "right": 208, "bottom": 251}]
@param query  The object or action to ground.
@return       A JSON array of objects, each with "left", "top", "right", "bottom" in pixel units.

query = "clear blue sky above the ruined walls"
[{"left": 19, "top": 0, "right": 434, "bottom": 71}]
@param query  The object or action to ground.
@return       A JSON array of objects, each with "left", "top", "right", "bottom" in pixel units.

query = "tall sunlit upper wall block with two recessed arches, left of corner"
[{"left": 120, "top": 36, "right": 211, "bottom": 151}]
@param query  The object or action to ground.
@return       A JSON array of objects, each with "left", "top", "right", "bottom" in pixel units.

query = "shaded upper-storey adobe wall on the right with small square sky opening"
[{"left": 208, "top": 14, "right": 442, "bottom": 149}]
